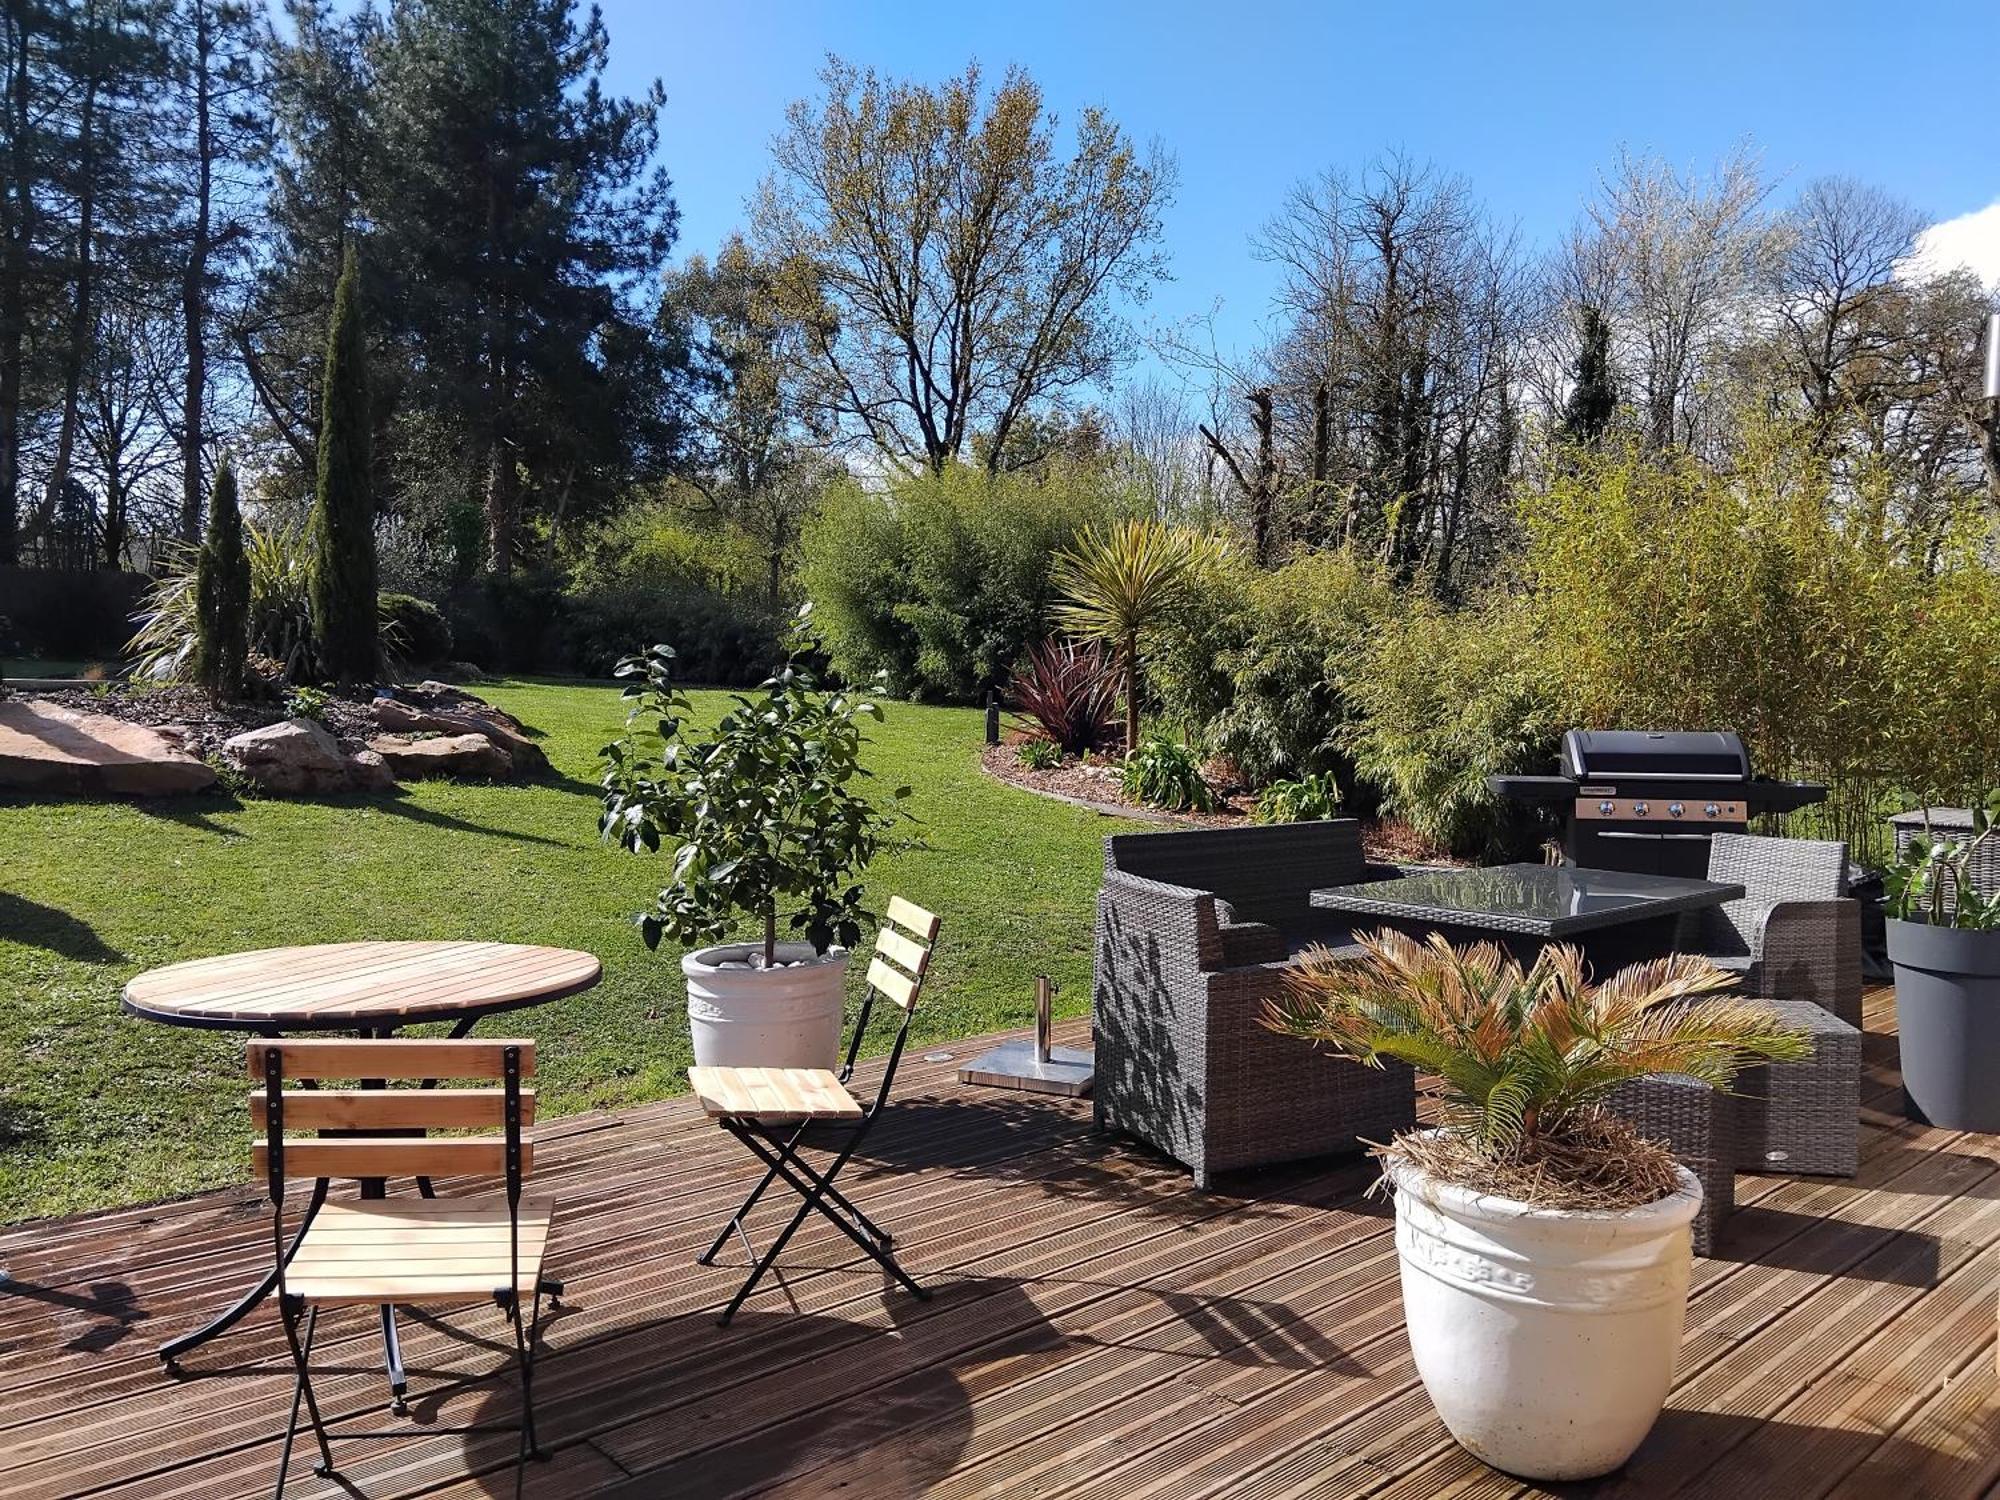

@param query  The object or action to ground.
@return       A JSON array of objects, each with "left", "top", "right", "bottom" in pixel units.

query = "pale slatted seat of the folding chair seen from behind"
[{"left": 284, "top": 1194, "right": 556, "bottom": 1306}]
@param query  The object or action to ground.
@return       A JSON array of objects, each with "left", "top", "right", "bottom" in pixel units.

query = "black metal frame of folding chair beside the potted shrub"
[{"left": 694, "top": 898, "right": 940, "bottom": 1328}]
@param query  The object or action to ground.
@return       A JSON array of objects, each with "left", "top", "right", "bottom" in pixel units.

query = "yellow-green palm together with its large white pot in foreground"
[{"left": 1266, "top": 932, "right": 1808, "bottom": 1480}]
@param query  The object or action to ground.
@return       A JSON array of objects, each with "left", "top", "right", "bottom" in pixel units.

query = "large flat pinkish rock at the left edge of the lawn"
[{"left": 0, "top": 698, "right": 216, "bottom": 796}]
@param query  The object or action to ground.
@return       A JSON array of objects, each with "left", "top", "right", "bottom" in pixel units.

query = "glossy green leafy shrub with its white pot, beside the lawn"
[{"left": 598, "top": 610, "right": 910, "bottom": 1068}]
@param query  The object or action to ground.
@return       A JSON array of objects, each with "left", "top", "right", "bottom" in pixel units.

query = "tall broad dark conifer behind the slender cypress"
[{"left": 362, "top": 0, "right": 676, "bottom": 572}]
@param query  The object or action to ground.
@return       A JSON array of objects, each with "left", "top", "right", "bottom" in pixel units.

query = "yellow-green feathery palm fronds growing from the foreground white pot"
[{"left": 1264, "top": 932, "right": 1812, "bottom": 1186}]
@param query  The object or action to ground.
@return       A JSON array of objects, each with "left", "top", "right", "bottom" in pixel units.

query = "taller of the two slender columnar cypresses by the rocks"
[{"left": 306, "top": 246, "right": 380, "bottom": 682}]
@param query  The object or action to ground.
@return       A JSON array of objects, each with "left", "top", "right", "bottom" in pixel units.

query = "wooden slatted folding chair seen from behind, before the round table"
[{"left": 248, "top": 1038, "right": 556, "bottom": 1496}]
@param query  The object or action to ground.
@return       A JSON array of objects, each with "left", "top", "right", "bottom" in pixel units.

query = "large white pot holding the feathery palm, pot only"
[{"left": 1386, "top": 1156, "right": 1702, "bottom": 1480}]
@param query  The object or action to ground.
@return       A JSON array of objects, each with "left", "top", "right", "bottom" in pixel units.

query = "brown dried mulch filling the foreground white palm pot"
[{"left": 1372, "top": 1110, "right": 1680, "bottom": 1210}]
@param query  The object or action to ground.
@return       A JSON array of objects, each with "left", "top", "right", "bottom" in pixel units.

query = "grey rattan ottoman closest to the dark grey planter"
[{"left": 1732, "top": 1000, "right": 1862, "bottom": 1178}]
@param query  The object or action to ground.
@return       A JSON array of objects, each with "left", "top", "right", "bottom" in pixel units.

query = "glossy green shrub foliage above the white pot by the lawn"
[{"left": 598, "top": 610, "right": 910, "bottom": 966}]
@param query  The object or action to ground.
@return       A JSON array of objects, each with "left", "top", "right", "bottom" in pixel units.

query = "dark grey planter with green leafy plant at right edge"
[{"left": 1882, "top": 790, "right": 2000, "bottom": 1130}]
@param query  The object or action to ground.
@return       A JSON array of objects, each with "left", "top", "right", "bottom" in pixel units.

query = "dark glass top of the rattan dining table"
[{"left": 1312, "top": 864, "right": 1744, "bottom": 936}]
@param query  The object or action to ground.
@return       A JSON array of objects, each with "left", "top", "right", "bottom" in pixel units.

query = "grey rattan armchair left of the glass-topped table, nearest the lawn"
[{"left": 1092, "top": 818, "right": 1416, "bottom": 1188}]
